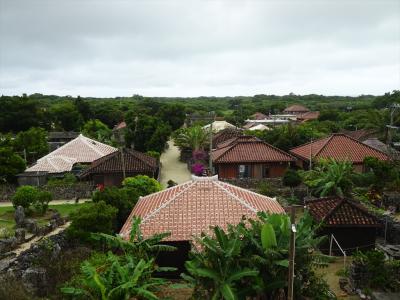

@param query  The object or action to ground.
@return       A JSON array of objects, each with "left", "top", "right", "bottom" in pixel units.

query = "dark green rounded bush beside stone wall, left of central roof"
[{"left": 67, "top": 201, "right": 118, "bottom": 241}]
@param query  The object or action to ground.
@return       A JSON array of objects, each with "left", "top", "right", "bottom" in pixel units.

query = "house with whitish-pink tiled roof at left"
[{"left": 18, "top": 134, "right": 117, "bottom": 185}]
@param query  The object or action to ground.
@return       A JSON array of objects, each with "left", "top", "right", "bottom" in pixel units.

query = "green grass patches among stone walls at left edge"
[{"left": 0, "top": 203, "right": 87, "bottom": 233}]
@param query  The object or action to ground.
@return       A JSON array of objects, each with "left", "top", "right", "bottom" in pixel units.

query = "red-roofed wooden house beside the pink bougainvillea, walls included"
[{"left": 211, "top": 136, "right": 295, "bottom": 179}]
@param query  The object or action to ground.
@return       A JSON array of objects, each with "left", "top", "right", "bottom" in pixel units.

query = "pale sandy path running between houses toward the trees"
[{"left": 160, "top": 141, "right": 191, "bottom": 186}]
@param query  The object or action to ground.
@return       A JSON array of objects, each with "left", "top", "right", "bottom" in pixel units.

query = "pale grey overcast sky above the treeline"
[{"left": 0, "top": 0, "right": 400, "bottom": 97}]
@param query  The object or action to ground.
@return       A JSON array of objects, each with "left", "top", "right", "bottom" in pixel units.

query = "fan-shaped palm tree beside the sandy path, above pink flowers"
[{"left": 175, "top": 126, "right": 210, "bottom": 151}]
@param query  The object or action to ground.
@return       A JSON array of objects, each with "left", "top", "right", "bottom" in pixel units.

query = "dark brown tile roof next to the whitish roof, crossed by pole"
[{"left": 81, "top": 149, "right": 158, "bottom": 177}]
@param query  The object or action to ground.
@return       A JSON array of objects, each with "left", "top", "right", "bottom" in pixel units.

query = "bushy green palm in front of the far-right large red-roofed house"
[{"left": 304, "top": 158, "right": 353, "bottom": 198}]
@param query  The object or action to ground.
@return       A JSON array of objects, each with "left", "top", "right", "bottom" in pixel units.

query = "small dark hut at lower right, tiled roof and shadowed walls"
[{"left": 306, "top": 197, "right": 380, "bottom": 255}]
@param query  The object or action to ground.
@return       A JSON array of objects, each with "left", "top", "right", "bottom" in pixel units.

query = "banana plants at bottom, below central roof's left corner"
[{"left": 61, "top": 218, "right": 175, "bottom": 300}]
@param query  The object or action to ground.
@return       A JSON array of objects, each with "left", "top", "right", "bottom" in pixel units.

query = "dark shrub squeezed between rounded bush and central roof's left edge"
[{"left": 92, "top": 187, "right": 133, "bottom": 229}]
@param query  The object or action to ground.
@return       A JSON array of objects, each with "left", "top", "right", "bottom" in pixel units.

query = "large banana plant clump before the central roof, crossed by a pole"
[{"left": 183, "top": 213, "right": 332, "bottom": 300}]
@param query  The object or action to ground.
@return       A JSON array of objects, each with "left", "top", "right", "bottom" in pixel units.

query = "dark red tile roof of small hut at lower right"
[{"left": 306, "top": 198, "right": 380, "bottom": 227}]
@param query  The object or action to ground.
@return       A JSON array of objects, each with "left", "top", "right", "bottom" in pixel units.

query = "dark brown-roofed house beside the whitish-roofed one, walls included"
[{"left": 80, "top": 149, "right": 159, "bottom": 186}]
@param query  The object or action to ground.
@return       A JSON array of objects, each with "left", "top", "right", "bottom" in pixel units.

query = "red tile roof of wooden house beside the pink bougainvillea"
[{"left": 211, "top": 139, "right": 294, "bottom": 163}]
